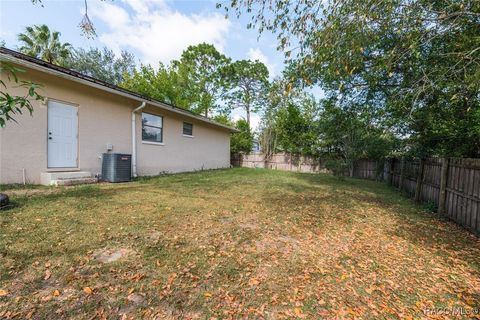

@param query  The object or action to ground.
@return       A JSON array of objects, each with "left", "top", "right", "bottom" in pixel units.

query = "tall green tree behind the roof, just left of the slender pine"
[{"left": 173, "top": 43, "right": 230, "bottom": 117}]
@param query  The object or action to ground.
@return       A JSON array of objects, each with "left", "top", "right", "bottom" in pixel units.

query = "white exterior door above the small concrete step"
[{"left": 47, "top": 101, "right": 78, "bottom": 168}]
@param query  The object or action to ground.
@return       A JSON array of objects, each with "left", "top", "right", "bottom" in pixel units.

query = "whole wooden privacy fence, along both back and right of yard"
[{"left": 231, "top": 153, "right": 480, "bottom": 234}]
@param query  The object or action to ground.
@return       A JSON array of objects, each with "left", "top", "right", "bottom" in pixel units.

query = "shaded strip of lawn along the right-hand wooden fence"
[{"left": 286, "top": 174, "right": 480, "bottom": 277}]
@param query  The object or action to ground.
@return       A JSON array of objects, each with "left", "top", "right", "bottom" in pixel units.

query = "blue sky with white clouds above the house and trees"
[{"left": 0, "top": 0, "right": 300, "bottom": 128}]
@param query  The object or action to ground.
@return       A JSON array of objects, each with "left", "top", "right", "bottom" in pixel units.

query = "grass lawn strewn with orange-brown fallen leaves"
[{"left": 0, "top": 168, "right": 480, "bottom": 319}]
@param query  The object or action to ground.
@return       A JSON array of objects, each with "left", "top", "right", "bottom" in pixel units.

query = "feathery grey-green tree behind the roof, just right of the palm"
[{"left": 65, "top": 47, "right": 135, "bottom": 85}]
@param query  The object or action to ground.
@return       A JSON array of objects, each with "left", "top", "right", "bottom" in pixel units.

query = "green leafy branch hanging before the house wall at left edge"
[{"left": 0, "top": 61, "right": 44, "bottom": 127}]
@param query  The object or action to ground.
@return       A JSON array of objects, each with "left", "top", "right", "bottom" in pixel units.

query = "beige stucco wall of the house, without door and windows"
[{"left": 0, "top": 67, "right": 230, "bottom": 184}]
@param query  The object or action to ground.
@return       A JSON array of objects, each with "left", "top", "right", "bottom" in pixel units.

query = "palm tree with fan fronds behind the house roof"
[{"left": 18, "top": 24, "right": 72, "bottom": 65}]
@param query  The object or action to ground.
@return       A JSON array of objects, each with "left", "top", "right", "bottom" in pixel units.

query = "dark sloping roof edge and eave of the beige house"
[{"left": 0, "top": 47, "right": 238, "bottom": 132}]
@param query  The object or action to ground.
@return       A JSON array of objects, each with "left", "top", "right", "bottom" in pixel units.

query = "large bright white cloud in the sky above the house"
[{"left": 91, "top": 0, "right": 230, "bottom": 65}]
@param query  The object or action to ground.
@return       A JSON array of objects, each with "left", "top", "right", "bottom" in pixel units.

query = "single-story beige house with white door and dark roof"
[{"left": 0, "top": 48, "right": 236, "bottom": 184}]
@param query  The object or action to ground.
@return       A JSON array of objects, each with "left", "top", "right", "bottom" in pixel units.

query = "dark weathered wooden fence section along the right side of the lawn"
[{"left": 384, "top": 158, "right": 480, "bottom": 234}]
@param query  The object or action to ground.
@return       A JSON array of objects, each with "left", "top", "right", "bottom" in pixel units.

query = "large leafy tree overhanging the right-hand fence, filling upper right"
[{"left": 226, "top": 0, "right": 480, "bottom": 156}]
